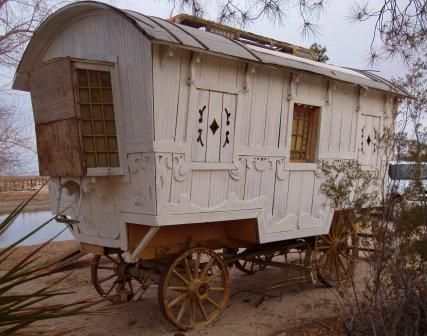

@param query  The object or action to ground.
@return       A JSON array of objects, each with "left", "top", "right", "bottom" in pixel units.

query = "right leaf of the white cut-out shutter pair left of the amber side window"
[{"left": 218, "top": 94, "right": 237, "bottom": 162}]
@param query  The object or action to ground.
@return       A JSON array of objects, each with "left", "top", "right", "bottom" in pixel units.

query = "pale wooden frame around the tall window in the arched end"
[{"left": 72, "top": 59, "right": 126, "bottom": 176}]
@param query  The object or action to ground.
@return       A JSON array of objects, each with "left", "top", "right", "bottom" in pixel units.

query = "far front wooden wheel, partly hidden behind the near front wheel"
[{"left": 91, "top": 253, "right": 146, "bottom": 303}]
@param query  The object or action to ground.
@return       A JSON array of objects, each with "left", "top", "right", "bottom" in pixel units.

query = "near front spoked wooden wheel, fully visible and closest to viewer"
[{"left": 158, "top": 248, "right": 229, "bottom": 330}]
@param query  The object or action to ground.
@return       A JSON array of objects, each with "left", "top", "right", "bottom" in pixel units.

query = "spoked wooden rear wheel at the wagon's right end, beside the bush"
[{"left": 313, "top": 221, "right": 359, "bottom": 288}]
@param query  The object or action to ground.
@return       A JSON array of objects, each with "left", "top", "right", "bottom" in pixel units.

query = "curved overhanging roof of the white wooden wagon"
[{"left": 13, "top": 1, "right": 408, "bottom": 96}]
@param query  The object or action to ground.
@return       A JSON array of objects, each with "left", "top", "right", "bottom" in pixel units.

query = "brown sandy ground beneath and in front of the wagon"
[{"left": 4, "top": 242, "right": 366, "bottom": 336}]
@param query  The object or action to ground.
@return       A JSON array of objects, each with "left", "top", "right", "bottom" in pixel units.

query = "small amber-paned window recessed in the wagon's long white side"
[{"left": 290, "top": 104, "right": 319, "bottom": 162}]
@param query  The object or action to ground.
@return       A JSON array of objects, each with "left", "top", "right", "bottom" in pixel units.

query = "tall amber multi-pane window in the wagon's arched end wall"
[{"left": 76, "top": 69, "right": 119, "bottom": 168}]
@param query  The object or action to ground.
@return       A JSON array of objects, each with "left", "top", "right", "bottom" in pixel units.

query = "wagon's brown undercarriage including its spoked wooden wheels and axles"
[{"left": 92, "top": 219, "right": 359, "bottom": 330}]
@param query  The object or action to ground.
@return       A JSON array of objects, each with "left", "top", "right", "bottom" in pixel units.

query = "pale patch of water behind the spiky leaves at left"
[{"left": 0, "top": 211, "right": 74, "bottom": 248}]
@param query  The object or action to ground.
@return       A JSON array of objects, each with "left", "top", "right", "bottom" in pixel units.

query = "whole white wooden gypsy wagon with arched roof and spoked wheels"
[{"left": 13, "top": 1, "right": 404, "bottom": 329}]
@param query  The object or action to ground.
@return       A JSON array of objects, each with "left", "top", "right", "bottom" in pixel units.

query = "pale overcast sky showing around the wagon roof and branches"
[{"left": 0, "top": 0, "right": 412, "bottom": 174}]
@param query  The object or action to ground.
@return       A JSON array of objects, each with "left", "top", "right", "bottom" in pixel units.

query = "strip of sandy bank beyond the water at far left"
[{"left": 0, "top": 186, "right": 50, "bottom": 215}]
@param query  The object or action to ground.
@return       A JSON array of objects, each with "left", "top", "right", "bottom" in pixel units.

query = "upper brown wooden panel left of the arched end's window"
[{"left": 30, "top": 58, "right": 77, "bottom": 124}]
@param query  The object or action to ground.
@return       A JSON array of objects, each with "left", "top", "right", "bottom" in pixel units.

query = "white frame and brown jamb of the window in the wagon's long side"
[{"left": 287, "top": 98, "right": 323, "bottom": 166}]
